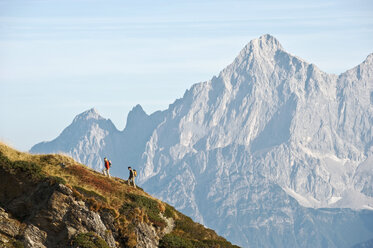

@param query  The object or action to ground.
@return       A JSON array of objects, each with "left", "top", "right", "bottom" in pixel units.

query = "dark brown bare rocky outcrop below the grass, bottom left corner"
[{"left": 0, "top": 177, "right": 116, "bottom": 247}]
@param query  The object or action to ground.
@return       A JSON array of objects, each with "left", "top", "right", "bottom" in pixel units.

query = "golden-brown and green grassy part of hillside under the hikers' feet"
[{"left": 0, "top": 143, "right": 237, "bottom": 248}]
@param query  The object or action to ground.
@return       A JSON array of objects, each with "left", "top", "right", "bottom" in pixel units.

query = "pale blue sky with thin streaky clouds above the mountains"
[{"left": 0, "top": 0, "right": 373, "bottom": 151}]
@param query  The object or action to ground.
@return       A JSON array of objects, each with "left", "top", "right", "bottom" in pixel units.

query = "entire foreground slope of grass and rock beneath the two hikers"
[{"left": 0, "top": 142, "right": 238, "bottom": 248}]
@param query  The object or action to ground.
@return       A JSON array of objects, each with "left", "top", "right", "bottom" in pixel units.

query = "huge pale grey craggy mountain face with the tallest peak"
[{"left": 31, "top": 35, "right": 373, "bottom": 247}]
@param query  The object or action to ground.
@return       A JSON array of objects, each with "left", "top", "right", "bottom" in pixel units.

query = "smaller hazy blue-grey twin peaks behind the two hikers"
[{"left": 30, "top": 105, "right": 163, "bottom": 177}]
